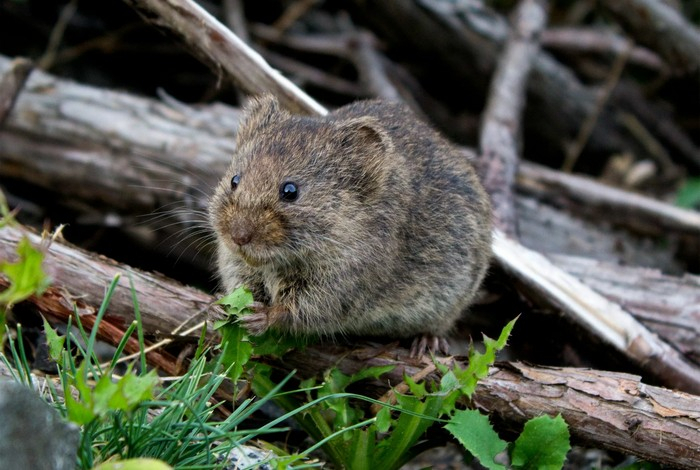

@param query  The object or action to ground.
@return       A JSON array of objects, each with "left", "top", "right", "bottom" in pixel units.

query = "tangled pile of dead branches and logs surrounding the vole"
[{"left": 0, "top": 0, "right": 700, "bottom": 468}]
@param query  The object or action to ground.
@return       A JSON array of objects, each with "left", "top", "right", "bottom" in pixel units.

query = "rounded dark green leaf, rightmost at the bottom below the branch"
[{"left": 511, "top": 415, "right": 571, "bottom": 470}]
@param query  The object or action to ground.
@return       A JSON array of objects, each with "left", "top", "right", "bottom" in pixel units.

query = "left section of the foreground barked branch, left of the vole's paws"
[{"left": 0, "top": 226, "right": 221, "bottom": 352}]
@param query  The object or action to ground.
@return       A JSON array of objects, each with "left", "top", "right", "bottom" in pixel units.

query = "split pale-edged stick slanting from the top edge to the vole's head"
[{"left": 124, "top": 0, "right": 327, "bottom": 114}]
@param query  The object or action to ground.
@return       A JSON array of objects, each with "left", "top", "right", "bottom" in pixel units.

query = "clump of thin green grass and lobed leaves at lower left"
[{"left": 0, "top": 276, "right": 312, "bottom": 470}]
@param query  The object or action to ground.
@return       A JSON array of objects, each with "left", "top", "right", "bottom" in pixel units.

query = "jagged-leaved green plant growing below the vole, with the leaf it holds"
[{"left": 216, "top": 288, "right": 570, "bottom": 470}]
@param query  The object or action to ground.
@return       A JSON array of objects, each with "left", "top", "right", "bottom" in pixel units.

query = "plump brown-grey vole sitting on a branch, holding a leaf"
[{"left": 209, "top": 96, "right": 491, "bottom": 355}]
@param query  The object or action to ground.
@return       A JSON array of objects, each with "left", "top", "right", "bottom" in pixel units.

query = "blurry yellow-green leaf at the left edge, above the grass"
[{"left": 0, "top": 237, "right": 50, "bottom": 306}]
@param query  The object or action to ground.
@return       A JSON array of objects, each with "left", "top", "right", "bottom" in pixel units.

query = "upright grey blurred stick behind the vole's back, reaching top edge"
[{"left": 479, "top": 0, "right": 547, "bottom": 237}]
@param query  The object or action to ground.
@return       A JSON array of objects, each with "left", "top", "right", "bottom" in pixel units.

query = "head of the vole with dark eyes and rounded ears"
[{"left": 209, "top": 96, "right": 401, "bottom": 266}]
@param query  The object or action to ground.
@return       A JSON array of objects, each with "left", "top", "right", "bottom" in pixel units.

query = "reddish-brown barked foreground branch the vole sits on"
[{"left": 0, "top": 226, "right": 700, "bottom": 468}]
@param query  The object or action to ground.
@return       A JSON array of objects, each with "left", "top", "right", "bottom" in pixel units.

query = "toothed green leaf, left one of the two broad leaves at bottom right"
[{"left": 445, "top": 410, "right": 507, "bottom": 470}]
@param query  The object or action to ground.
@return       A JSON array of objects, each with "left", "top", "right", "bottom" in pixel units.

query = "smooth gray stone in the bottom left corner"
[{"left": 0, "top": 378, "right": 80, "bottom": 470}]
